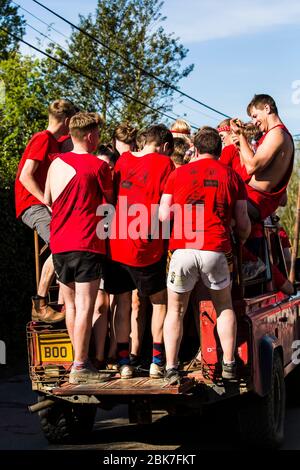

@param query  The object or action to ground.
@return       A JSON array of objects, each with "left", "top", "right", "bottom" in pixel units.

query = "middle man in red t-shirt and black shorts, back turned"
[{"left": 104, "top": 125, "right": 174, "bottom": 378}]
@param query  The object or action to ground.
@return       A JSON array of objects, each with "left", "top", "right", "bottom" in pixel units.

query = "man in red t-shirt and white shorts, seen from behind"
[{"left": 160, "top": 127, "right": 250, "bottom": 383}]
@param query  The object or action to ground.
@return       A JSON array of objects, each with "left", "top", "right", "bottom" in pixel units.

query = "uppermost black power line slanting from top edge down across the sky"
[{"left": 33, "top": 0, "right": 230, "bottom": 118}]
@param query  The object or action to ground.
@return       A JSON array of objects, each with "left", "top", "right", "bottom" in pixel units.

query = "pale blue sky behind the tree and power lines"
[{"left": 16, "top": 0, "right": 300, "bottom": 134}]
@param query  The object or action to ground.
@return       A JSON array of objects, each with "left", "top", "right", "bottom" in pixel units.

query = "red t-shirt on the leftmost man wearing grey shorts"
[{"left": 15, "top": 130, "right": 59, "bottom": 217}]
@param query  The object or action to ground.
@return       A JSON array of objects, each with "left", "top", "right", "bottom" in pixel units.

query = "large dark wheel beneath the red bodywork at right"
[{"left": 238, "top": 351, "right": 285, "bottom": 448}]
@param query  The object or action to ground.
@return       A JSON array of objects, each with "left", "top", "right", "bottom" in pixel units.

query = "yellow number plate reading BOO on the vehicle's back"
[{"left": 37, "top": 333, "right": 73, "bottom": 363}]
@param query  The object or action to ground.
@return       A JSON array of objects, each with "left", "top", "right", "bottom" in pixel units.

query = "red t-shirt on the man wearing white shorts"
[{"left": 164, "top": 158, "right": 247, "bottom": 253}]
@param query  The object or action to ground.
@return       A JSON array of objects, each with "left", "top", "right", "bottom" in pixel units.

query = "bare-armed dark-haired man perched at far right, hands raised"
[{"left": 230, "top": 95, "right": 294, "bottom": 220}]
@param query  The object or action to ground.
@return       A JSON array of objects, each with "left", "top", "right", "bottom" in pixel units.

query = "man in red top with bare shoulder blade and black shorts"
[{"left": 45, "top": 113, "right": 113, "bottom": 384}]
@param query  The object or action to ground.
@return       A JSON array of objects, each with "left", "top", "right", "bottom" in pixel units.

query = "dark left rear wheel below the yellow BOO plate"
[{"left": 38, "top": 395, "right": 97, "bottom": 444}]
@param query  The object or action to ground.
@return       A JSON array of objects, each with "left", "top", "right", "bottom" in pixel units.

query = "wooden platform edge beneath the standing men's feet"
[{"left": 51, "top": 377, "right": 195, "bottom": 396}]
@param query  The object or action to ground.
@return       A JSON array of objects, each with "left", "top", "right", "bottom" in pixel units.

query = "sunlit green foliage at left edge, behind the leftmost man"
[{"left": 0, "top": 53, "right": 48, "bottom": 188}]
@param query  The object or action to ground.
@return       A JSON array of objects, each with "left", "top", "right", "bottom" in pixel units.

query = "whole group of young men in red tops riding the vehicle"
[{"left": 16, "top": 95, "right": 294, "bottom": 383}]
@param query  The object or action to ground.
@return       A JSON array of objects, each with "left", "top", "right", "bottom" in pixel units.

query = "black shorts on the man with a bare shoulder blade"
[{"left": 53, "top": 251, "right": 105, "bottom": 284}]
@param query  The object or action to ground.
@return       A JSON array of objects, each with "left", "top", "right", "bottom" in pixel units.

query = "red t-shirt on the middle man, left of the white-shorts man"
[{"left": 109, "top": 152, "right": 174, "bottom": 267}]
